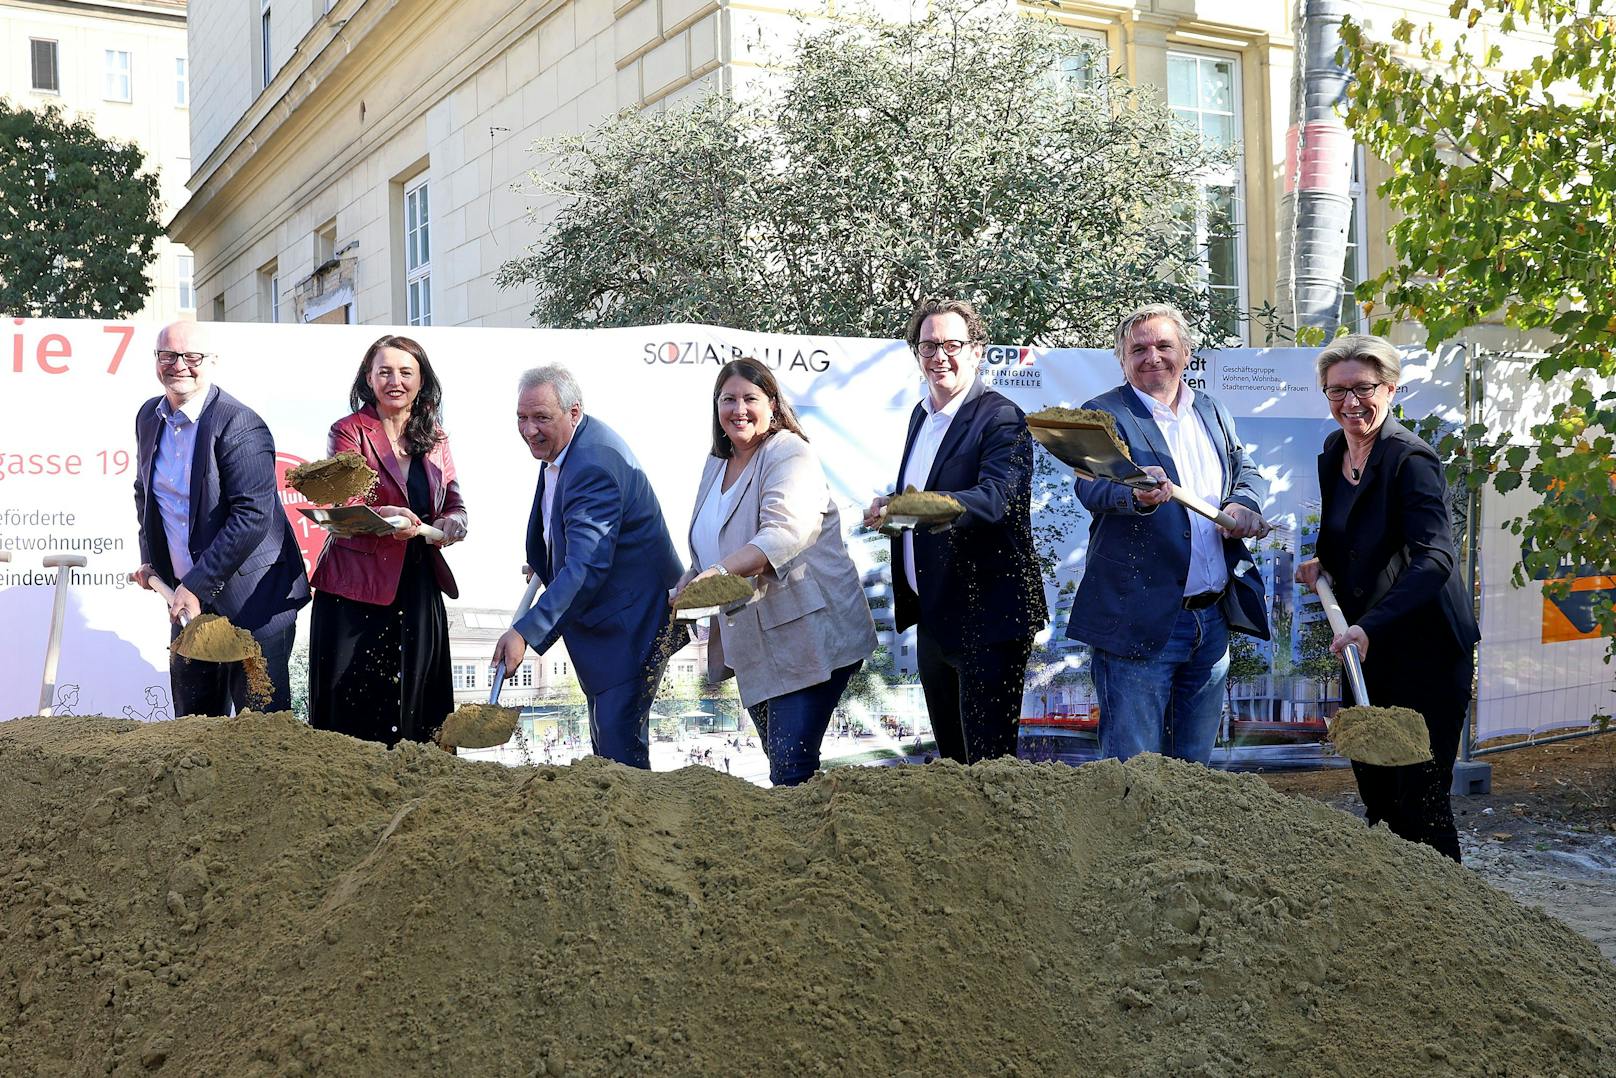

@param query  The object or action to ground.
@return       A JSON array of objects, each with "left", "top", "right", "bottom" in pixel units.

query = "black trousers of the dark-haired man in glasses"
[{"left": 915, "top": 625, "right": 1033, "bottom": 763}]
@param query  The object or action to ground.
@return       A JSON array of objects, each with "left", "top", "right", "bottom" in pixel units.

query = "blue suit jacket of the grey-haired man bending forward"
[{"left": 516, "top": 415, "right": 682, "bottom": 697}]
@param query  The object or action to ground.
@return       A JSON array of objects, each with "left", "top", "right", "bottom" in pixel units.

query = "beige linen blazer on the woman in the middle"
[{"left": 690, "top": 430, "right": 876, "bottom": 708}]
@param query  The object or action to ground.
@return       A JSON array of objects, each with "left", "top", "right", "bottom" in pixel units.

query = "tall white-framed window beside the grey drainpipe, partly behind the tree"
[{"left": 1167, "top": 52, "right": 1246, "bottom": 341}]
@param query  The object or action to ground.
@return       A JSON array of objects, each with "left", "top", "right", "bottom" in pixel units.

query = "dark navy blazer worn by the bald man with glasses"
[{"left": 134, "top": 386, "right": 309, "bottom": 632}]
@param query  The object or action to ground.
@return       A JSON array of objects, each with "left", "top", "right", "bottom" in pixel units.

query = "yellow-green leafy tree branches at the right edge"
[{"left": 1343, "top": 0, "right": 1616, "bottom": 651}]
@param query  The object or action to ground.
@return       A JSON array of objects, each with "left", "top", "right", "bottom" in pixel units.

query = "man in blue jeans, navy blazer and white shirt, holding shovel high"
[{"left": 1067, "top": 304, "right": 1269, "bottom": 763}]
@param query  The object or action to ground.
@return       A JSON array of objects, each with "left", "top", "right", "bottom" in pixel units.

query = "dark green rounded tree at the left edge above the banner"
[{"left": 0, "top": 99, "right": 163, "bottom": 318}]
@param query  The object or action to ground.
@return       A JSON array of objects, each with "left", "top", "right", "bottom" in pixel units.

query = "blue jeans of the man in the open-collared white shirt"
[{"left": 1094, "top": 604, "right": 1228, "bottom": 763}]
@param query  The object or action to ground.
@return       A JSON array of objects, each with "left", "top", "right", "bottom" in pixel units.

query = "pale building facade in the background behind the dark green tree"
[{"left": 0, "top": 0, "right": 196, "bottom": 322}]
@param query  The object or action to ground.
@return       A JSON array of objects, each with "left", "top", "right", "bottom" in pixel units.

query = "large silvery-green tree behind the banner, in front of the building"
[{"left": 499, "top": 0, "right": 1214, "bottom": 344}]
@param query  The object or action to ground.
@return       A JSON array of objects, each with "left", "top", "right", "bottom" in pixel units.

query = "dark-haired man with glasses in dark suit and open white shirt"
[{"left": 865, "top": 299, "right": 1049, "bottom": 763}]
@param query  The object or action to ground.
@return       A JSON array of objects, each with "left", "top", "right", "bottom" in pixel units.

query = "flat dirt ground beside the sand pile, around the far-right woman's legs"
[{"left": 1262, "top": 734, "right": 1616, "bottom": 960}]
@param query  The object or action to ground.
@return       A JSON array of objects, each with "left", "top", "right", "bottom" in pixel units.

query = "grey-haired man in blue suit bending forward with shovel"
[{"left": 493, "top": 364, "right": 682, "bottom": 768}]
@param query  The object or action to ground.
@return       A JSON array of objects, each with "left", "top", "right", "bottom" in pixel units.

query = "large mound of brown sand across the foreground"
[{"left": 0, "top": 714, "right": 1616, "bottom": 1078}]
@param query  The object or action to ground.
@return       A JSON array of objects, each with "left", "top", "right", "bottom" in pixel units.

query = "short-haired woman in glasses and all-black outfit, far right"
[{"left": 1296, "top": 335, "right": 1482, "bottom": 860}]
